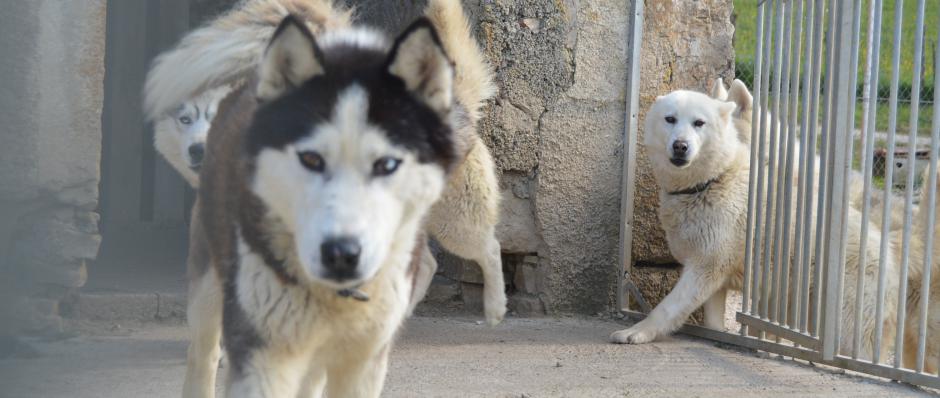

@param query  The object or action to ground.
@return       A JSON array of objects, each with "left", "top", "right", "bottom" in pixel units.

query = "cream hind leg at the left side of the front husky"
[{"left": 183, "top": 269, "right": 222, "bottom": 398}]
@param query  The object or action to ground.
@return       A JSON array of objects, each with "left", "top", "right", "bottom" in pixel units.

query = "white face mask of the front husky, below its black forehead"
[{"left": 252, "top": 85, "right": 445, "bottom": 289}]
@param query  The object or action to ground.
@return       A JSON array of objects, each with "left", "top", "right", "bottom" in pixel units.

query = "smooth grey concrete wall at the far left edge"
[{"left": 0, "top": 0, "right": 106, "bottom": 332}]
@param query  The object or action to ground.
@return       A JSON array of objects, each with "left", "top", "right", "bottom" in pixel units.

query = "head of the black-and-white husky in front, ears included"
[{"left": 248, "top": 17, "right": 454, "bottom": 288}]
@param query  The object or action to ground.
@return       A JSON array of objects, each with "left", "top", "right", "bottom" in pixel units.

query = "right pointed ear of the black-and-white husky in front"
[{"left": 387, "top": 18, "right": 454, "bottom": 115}]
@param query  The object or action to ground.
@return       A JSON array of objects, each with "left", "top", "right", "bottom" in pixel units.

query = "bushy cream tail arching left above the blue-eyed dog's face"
[{"left": 144, "top": 0, "right": 351, "bottom": 119}]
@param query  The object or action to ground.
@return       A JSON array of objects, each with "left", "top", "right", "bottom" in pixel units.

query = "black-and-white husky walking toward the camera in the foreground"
[{"left": 199, "top": 13, "right": 455, "bottom": 397}]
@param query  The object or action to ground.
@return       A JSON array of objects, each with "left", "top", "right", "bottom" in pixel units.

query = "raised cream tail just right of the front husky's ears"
[{"left": 425, "top": 0, "right": 496, "bottom": 123}]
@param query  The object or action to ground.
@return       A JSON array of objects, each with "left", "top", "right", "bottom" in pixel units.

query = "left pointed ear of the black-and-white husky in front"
[{"left": 256, "top": 15, "right": 323, "bottom": 101}]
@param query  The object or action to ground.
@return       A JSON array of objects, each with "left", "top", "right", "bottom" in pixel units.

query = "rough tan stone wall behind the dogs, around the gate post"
[{"left": 350, "top": 0, "right": 734, "bottom": 314}]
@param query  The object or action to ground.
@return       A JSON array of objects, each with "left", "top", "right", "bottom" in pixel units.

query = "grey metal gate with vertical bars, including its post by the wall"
[{"left": 620, "top": 0, "right": 940, "bottom": 388}]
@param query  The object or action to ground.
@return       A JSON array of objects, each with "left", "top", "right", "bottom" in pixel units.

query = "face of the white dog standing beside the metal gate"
[{"left": 644, "top": 90, "right": 735, "bottom": 168}]
